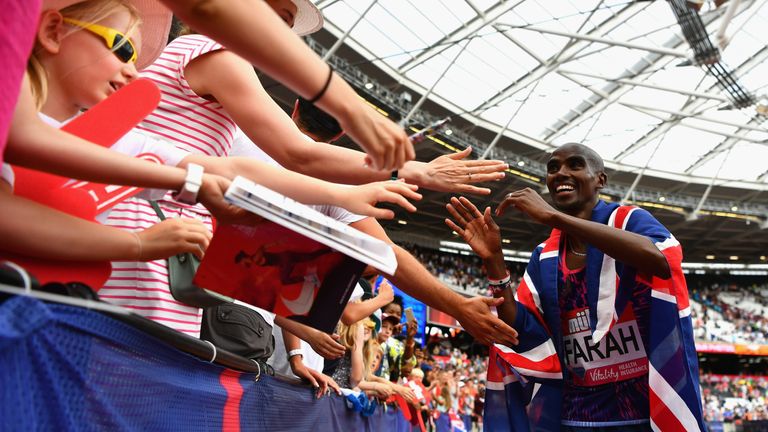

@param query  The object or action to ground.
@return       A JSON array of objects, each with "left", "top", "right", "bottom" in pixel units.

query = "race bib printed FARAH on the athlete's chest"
[{"left": 561, "top": 306, "right": 648, "bottom": 387}]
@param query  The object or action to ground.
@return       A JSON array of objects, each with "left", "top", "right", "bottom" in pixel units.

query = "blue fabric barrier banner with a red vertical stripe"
[{"left": 0, "top": 296, "right": 411, "bottom": 431}]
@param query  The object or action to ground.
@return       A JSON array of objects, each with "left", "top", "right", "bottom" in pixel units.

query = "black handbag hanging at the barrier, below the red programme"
[{"left": 200, "top": 303, "right": 275, "bottom": 361}]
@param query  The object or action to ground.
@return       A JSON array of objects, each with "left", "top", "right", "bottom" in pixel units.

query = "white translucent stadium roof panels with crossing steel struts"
[{"left": 317, "top": 0, "right": 768, "bottom": 189}]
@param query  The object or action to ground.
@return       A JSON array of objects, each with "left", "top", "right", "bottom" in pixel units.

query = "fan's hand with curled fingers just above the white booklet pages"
[{"left": 338, "top": 181, "right": 421, "bottom": 219}]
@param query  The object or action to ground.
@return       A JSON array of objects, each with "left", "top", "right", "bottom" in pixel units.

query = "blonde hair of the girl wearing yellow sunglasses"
[{"left": 27, "top": 0, "right": 141, "bottom": 110}]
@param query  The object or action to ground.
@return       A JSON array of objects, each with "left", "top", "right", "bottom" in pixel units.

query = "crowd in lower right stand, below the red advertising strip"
[{"left": 700, "top": 374, "right": 768, "bottom": 422}]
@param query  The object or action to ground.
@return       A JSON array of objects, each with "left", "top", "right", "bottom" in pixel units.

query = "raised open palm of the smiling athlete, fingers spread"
[{"left": 445, "top": 197, "right": 501, "bottom": 259}]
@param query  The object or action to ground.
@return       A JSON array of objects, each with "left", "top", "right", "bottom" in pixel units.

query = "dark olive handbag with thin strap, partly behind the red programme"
[{"left": 149, "top": 201, "right": 232, "bottom": 308}]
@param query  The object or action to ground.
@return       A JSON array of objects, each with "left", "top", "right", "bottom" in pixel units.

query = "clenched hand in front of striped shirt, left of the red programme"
[{"left": 136, "top": 218, "right": 212, "bottom": 261}]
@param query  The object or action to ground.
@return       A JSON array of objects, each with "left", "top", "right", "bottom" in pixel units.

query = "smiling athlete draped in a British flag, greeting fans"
[{"left": 446, "top": 144, "right": 704, "bottom": 431}]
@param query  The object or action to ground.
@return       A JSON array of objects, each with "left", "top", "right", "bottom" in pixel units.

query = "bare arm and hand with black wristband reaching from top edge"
[{"left": 162, "top": 0, "right": 415, "bottom": 171}]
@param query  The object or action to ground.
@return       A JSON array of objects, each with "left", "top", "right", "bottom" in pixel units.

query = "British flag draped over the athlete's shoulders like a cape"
[{"left": 483, "top": 201, "right": 706, "bottom": 432}]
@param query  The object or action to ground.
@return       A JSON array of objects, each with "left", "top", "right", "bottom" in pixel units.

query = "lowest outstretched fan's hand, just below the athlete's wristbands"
[{"left": 456, "top": 297, "right": 518, "bottom": 347}]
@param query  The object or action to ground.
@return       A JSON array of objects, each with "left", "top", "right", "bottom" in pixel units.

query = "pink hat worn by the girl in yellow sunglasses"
[{"left": 42, "top": 0, "right": 172, "bottom": 70}]
